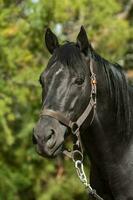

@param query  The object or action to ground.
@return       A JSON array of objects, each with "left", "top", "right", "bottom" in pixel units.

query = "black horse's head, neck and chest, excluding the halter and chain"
[{"left": 33, "top": 27, "right": 133, "bottom": 200}]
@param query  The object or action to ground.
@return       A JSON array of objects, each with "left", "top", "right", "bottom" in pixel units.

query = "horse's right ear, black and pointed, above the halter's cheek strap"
[{"left": 77, "top": 26, "right": 91, "bottom": 55}]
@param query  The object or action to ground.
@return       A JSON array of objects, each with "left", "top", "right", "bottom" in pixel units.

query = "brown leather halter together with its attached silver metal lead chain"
[{"left": 40, "top": 60, "right": 103, "bottom": 200}]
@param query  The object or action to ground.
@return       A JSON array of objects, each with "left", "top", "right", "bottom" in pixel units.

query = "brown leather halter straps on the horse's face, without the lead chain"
[{"left": 40, "top": 59, "right": 97, "bottom": 157}]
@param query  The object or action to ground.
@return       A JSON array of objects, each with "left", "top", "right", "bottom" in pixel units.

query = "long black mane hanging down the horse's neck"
[{"left": 92, "top": 51, "right": 131, "bottom": 139}]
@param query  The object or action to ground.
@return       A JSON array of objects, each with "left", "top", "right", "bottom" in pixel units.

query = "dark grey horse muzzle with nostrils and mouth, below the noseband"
[{"left": 32, "top": 117, "right": 66, "bottom": 157}]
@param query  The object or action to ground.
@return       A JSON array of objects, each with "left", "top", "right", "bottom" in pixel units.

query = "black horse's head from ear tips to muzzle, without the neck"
[{"left": 33, "top": 27, "right": 92, "bottom": 157}]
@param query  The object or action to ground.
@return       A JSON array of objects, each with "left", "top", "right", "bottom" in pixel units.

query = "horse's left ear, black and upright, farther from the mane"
[{"left": 45, "top": 28, "right": 59, "bottom": 54}]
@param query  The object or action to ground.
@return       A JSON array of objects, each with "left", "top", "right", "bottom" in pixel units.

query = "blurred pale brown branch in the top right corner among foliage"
[{"left": 117, "top": 0, "right": 133, "bottom": 19}]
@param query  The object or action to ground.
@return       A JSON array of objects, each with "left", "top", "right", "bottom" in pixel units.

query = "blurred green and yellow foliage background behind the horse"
[{"left": 0, "top": 0, "right": 133, "bottom": 200}]
